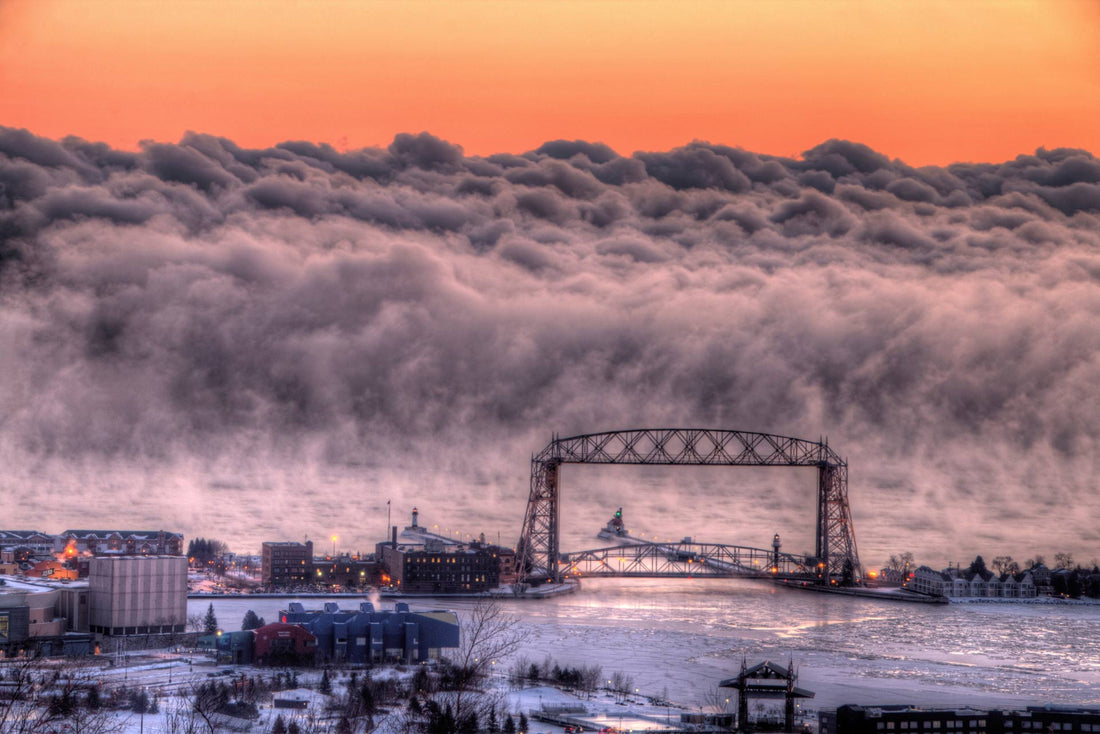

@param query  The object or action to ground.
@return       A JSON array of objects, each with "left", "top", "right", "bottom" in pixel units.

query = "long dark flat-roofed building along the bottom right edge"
[{"left": 818, "top": 705, "right": 1100, "bottom": 734}]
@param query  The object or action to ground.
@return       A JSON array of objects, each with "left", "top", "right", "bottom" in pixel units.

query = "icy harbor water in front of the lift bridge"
[{"left": 188, "top": 579, "right": 1100, "bottom": 709}]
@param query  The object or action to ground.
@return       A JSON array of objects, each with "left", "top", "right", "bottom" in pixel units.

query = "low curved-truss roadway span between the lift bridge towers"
[{"left": 559, "top": 537, "right": 816, "bottom": 581}]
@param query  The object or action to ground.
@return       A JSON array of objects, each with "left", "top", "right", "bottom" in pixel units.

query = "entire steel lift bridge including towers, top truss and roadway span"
[{"left": 516, "top": 428, "right": 862, "bottom": 584}]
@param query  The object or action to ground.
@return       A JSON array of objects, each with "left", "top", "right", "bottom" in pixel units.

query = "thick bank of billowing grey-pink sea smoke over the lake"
[{"left": 0, "top": 124, "right": 1100, "bottom": 565}]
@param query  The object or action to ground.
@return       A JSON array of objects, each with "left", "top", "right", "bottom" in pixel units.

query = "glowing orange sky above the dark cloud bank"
[{"left": 0, "top": 0, "right": 1100, "bottom": 164}]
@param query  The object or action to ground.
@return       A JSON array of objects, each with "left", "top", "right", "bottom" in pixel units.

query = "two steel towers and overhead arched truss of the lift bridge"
[{"left": 516, "top": 428, "right": 862, "bottom": 584}]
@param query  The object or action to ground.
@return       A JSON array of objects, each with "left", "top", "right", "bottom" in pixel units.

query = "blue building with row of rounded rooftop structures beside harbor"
[{"left": 283, "top": 602, "right": 459, "bottom": 664}]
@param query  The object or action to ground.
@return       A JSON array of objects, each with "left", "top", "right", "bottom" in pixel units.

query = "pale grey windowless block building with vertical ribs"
[{"left": 88, "top": 556, "right": 187, "bottom": 636}]
